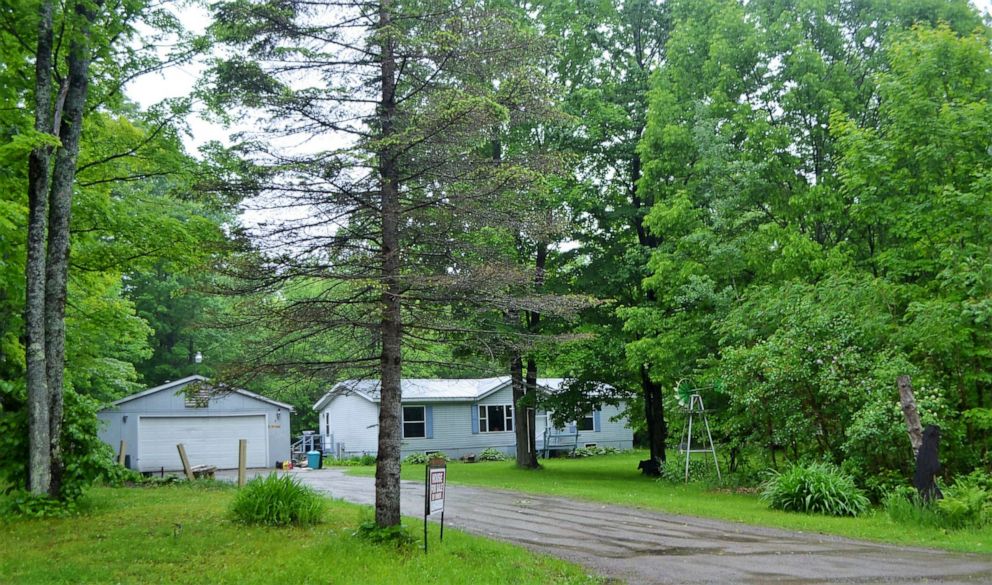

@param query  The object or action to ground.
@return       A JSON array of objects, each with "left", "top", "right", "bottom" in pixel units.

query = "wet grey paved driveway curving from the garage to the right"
[{"left": 223, "top": 469, "right": 992, "bottom": 585}]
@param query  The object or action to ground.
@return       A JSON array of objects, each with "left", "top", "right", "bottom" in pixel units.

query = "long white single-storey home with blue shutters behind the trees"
[{"left": 314, "top": 377, "right": 633, "bottom": 457}]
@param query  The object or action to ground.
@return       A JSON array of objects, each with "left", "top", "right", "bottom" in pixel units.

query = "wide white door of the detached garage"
[{"left": 138, "top": 414, "right": 269, "bottom": 471}]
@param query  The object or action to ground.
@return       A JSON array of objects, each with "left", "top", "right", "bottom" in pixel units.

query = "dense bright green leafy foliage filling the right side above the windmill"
[{"left": 618, "top": 0, "right": 992, "bottom": 480}]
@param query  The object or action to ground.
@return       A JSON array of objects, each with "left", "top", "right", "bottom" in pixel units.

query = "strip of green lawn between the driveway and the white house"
[{"left": 349, "top": 451, "right": 992, "bottom": 554}]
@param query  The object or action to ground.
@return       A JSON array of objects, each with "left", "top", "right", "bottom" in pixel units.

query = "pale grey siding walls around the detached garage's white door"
[{"left": 97, "top": 378, "right": 290, "bottom": 468}]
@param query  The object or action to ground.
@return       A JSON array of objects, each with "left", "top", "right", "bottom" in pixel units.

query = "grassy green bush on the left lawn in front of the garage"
[{"left": 231, "top": 473, "right": 325, "bottom": 526}]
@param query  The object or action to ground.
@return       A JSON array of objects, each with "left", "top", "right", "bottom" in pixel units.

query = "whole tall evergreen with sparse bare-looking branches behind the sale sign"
[{"left": 212, "top": 0, "right": 560, "bottom": 526}]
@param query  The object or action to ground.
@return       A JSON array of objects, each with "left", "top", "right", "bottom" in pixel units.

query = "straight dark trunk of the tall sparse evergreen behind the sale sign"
[{"left": 375, "top": 0, "right": 403, "bottom": 528}]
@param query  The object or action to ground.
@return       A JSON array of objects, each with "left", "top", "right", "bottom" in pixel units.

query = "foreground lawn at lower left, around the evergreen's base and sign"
[{"left": 0, "top": 485, "right": 599, "bottom": 585}]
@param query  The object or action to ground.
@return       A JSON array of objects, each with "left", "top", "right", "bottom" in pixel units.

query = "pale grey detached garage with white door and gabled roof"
[{"left": 99, "top": 376, "right": 293, "bottom": 471}]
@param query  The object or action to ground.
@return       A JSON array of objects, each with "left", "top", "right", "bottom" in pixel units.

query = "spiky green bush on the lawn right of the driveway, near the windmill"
[{"left": 761, "top": 463, "right": 869, "bottom": 516}]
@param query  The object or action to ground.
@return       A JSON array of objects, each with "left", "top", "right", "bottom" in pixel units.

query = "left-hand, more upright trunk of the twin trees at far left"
[{"left": 24, "top": 0, "right": 53, "bottom": 494}]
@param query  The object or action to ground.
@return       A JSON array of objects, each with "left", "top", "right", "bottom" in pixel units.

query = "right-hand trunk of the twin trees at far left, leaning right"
[{"left": 45, "top": 4, "right": 94, "bottom": 497}]
